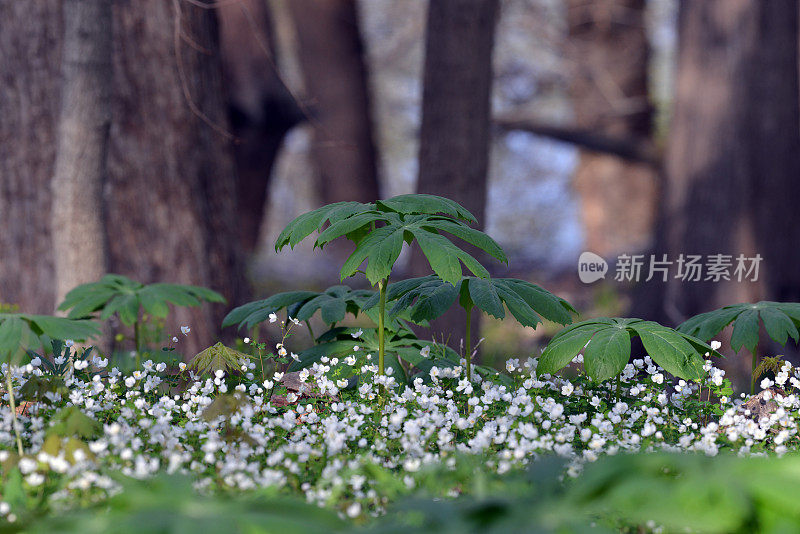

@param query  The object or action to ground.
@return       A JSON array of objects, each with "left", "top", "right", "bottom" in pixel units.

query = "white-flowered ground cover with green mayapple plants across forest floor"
[{"left": 0, "top": 195, "right": 800, "bottom": 532}]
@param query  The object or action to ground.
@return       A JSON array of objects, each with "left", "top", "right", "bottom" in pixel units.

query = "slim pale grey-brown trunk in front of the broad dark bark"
[{"left": 50, "top": 0, "right": 112, "bottom": 310}]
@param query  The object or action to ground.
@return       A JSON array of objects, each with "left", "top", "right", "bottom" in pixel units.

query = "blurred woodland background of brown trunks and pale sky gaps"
[{"left": 0, "top": 0, "right": 800, "bottom": 388}]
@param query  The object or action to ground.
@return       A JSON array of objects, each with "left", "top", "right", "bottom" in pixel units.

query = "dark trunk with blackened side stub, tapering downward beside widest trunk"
[{"left": 218, "top": 0, "right": 303, "bottom": 253}]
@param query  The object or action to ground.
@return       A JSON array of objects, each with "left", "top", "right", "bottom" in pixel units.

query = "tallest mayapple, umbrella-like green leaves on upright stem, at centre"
[{"left": 275, "top": 194, "right": 508, "bottom": 375}]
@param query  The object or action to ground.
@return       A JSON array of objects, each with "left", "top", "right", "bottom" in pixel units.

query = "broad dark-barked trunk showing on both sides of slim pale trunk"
[{"left": 0, "top": 0, "right": 242, "bottom": 354}]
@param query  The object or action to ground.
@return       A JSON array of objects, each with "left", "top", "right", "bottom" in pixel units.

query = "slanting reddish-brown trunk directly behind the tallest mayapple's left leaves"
[{"left": 288, "top": 0, "right": 379, "bottom": 204}]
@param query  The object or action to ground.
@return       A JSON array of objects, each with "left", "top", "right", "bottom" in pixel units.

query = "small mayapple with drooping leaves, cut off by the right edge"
[{"left": 678, "top": 301, "right": 800, "bottom": 395}]
